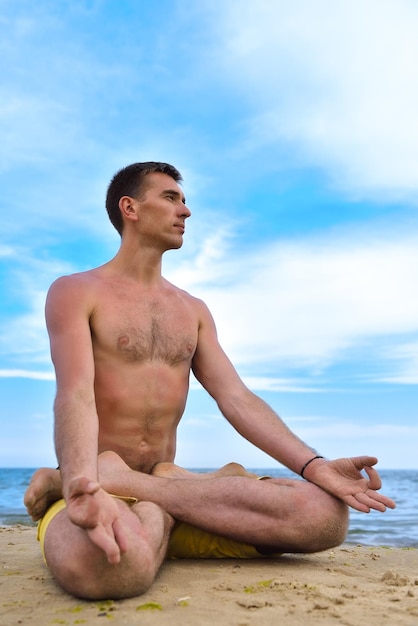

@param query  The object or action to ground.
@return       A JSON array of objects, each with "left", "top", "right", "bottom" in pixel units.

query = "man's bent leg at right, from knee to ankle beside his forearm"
[{"left": 99, "top": 452, "right": 348, "bottom": 553}]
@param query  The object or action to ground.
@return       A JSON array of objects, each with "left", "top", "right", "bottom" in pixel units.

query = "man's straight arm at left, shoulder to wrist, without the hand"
[{"left": 46, "top": 275, "right": 99, "bottom": 499}]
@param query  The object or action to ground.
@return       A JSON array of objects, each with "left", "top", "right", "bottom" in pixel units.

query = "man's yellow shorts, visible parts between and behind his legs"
[{"left": 38, "top": 496, "right": 278, "bottom": 560}]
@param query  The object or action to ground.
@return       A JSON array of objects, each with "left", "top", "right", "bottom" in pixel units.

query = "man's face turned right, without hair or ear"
[{"left": 135, "top": 172, "right": 191, "bottom": 250}]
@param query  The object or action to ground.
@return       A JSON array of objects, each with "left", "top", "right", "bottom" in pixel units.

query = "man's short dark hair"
[{"left": 106, "top": 161, "right": 183, "bottom": 235}]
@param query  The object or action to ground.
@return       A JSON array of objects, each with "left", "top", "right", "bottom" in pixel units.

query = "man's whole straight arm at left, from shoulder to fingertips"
[{"left": 46, "top": 275, "right": 127, "bottom": 563}]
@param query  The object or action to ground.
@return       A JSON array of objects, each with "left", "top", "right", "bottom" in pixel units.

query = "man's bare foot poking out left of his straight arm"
[{"left": 23, "top": 467, "right": 62, "bottom": 522}]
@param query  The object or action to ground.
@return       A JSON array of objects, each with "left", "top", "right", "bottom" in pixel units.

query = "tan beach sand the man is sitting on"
[{"left": 0, "top": 526, "right": 418, "bottom": 626}]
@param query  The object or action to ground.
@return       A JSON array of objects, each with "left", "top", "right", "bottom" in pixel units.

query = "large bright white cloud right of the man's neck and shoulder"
[{"left": 170, "top": 217, "right": 418, "bottom": 374}]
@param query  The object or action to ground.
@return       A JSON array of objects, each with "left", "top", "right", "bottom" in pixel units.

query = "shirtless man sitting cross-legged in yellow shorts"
[{"left": 25, "top": 162, "right": 395, "bottom": 598}]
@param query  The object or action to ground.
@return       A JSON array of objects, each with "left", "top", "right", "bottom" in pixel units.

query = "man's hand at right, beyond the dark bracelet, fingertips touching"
[{"left": 305, "top": 456, "right": 396, "bottom": 513}]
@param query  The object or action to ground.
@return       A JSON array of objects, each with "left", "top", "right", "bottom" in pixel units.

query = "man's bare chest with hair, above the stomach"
[{"left": 92, "top": 298, "right": 198, "bottom": 365}]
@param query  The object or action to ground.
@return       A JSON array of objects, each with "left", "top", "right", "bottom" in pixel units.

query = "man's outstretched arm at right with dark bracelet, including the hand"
[{"left": 193, "top": 301, "right": 394, "bottom": 512}]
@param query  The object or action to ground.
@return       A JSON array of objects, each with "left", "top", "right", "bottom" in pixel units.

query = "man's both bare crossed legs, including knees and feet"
[{"left": 25, "top": 452, "right": 348, "bottom": 599}]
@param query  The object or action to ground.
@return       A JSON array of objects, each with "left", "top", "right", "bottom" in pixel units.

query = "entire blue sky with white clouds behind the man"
[{"left": 0, "top": 0, "right": 418, "bottom": 468}]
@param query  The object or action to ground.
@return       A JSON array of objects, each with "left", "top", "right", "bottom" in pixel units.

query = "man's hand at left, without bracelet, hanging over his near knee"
[{"left": 66, "top": 476, "right": 128, "bottom": 563}]
